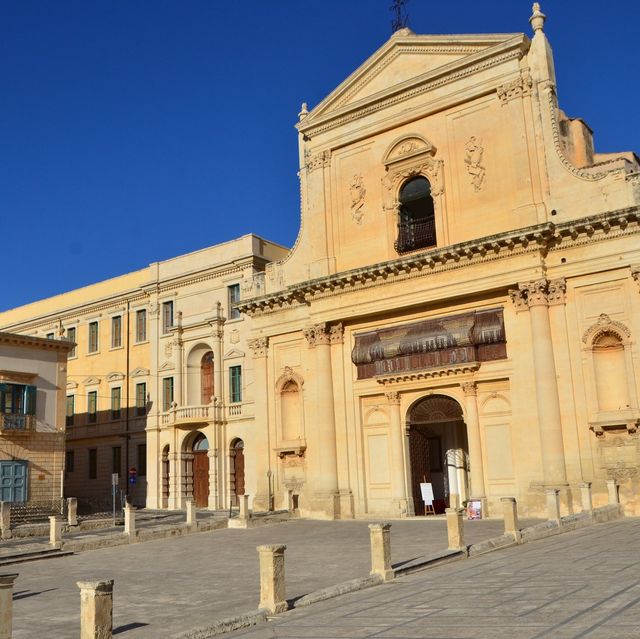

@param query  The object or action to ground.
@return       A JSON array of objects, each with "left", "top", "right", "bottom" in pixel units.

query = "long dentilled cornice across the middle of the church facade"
[{"left": 236, "top": 207, "right": 640, "bottom": 316}]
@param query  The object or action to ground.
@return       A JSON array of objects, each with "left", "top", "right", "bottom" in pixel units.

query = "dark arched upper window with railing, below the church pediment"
[{"left": 395, "top": 176, "right": 436, "bottom": 253}]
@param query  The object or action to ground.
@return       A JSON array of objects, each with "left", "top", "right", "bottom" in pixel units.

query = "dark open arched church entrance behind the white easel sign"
[{"left": 407, "top": 395, "right": 469, "bottom": 514}]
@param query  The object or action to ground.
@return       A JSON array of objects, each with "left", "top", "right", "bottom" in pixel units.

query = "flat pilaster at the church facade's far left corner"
[{"left": 245, "top": 337, "right": 271, "bottom": 511}]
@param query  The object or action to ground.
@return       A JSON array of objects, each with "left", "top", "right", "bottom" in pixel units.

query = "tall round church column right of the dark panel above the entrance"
[{"left": 519, "top": 279, "right": 567, "bottom": 486}]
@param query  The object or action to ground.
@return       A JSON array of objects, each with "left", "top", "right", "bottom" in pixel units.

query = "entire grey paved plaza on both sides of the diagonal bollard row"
[{"left": 3, "top": 519, "right": 640, "bottom": 639}]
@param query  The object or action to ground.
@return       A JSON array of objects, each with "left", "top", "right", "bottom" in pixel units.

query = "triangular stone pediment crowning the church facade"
[{"left": 299, "top": 29, "right": 527, "bottom": 129}]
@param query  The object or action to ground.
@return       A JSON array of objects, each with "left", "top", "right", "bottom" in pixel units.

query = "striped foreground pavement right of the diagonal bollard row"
[{"left": 226, "top": 519, "right": 640, "bottom": 639}]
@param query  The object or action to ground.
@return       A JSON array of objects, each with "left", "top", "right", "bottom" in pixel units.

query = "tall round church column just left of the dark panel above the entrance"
[{"left": 303, "top": 322, "right": 339, "bottom": 518}]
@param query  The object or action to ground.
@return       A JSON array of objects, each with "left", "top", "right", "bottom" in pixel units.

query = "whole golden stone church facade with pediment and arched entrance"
[{"left": 238, "top": 4, "right": 640, "bottom": 518}]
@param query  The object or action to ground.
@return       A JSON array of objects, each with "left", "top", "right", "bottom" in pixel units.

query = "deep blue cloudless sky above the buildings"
[{"left": 0, "top": 0, "right": 640, "bottom": 309}]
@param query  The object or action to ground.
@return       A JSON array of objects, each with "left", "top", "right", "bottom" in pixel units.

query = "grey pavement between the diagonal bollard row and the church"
[{"left": 6, "top": 519, "right": 526, "bottom": 639}]
